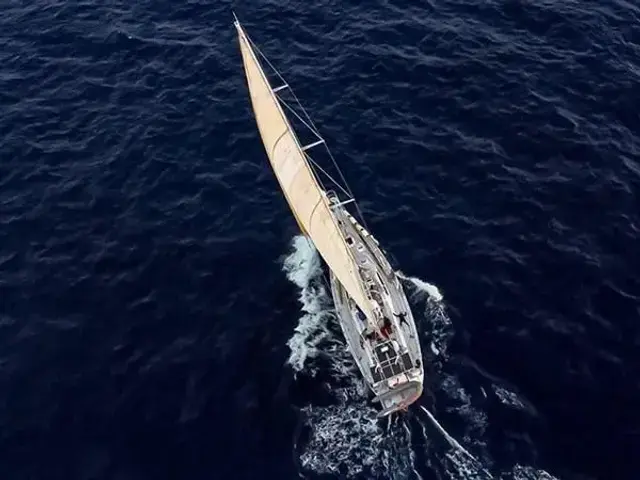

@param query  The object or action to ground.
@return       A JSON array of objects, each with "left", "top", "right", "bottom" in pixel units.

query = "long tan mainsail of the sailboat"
[{"left": 235, "top": 22, "right": 373, "bottom": 319}]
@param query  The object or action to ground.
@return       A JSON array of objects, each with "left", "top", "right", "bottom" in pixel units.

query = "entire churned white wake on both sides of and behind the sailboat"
[{"left": 283, "top": 236, "right": 557, "bottom": 480}]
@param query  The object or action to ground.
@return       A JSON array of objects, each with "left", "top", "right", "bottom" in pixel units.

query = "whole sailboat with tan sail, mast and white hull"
[{"left": 234, "top": 15, "right": 424, "bottom": 417}]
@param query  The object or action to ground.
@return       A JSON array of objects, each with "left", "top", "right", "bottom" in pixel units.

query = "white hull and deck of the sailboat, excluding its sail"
[{"left": 331, "top": 199, "right": 424, "bottom": 416}]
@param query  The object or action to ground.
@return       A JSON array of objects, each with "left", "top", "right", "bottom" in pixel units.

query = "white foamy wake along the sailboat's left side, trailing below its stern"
[{"left": 283, "top": 236, "right": 411, "bottom": 479}]
